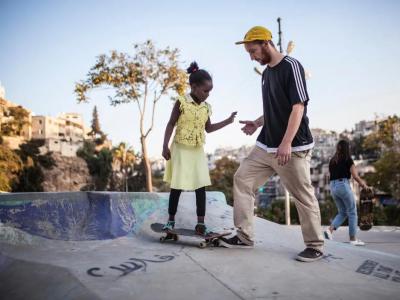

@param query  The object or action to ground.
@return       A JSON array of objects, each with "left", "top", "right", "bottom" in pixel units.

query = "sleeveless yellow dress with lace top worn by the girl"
[{"left": 164, "top": 94, "right": 211, "bottom": 190}]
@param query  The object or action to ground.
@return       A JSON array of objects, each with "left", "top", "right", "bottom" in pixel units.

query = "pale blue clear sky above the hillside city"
[{"left": 0, "top": 0, "right": 400, "bottom": 158}]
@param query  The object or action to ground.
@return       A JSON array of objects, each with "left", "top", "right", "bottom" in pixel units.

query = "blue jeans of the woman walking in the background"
[{"left": 330, "top": 178, "right": 357, "bottom": 237}]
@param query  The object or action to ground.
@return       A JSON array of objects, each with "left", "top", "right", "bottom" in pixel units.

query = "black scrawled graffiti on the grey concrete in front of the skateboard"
[{"left": 86, "top": 255, "right": 175, "bottom": 277}]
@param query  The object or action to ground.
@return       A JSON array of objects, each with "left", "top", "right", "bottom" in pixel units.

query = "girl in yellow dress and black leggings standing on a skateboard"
[{"left": 162, "top": 62, "right": 236, "bottom": 235}]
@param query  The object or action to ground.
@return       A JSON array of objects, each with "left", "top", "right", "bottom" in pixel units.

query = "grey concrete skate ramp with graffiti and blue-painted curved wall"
[{"left": 0, "top": 192, "right": 400, "bottom": 300}]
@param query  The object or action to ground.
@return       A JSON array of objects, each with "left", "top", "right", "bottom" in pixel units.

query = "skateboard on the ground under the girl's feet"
[{"left": 150, "top": 223, "right": 231, "bottom": 248}]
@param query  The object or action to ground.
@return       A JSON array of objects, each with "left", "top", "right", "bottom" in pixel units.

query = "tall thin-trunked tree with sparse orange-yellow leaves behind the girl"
[{"left": 75, "top": 41, "right": 187, "bottom": 192}]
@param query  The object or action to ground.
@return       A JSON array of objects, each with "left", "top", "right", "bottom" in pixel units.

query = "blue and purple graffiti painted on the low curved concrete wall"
[{"left": 0, "top": 192, "right": 137, "bottom": 241}]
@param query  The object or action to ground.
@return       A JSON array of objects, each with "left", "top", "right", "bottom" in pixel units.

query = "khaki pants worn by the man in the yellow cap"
[{"left": 233, "top": 146, "right": 324, "bottom": 250}]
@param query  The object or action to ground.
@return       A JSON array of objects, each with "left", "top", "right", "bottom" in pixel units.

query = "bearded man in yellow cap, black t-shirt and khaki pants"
[{"left": 222, "top": 26, "right": 324, "bottom": 262}]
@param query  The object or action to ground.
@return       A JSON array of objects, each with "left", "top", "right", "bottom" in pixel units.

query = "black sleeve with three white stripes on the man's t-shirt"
[{"left": 285, "top": 56, "right": 309, "bottom": 105}]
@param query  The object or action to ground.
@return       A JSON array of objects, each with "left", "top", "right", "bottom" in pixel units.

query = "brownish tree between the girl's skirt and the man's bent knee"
[{"left": 207, "top": 156, "right": 239, "bottom": 205}]
